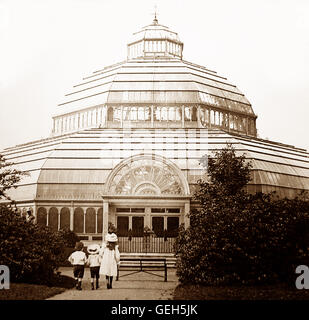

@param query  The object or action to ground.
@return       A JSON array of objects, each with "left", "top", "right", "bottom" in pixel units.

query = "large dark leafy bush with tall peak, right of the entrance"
[{"left": 177, "top": 147, "right": 309, "bottom": 285}]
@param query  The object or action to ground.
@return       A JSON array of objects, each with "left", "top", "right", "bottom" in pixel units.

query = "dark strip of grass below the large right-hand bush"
[{"left": 174, "top": 284, "right": 309, "bottom": 300}]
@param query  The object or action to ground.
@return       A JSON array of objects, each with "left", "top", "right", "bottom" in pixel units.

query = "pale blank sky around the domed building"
[{"left": 0, "top": 0, "right": 309, "bottom": 152}]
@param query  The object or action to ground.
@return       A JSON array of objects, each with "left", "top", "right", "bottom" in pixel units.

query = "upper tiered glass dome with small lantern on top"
[{"left": 53, "top": 18, "right": 257, "bottom": 136}]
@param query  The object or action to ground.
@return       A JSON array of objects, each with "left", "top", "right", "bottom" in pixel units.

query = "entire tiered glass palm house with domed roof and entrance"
[{"left": 3, "top": 18, "right": 309, "bottom": 254}]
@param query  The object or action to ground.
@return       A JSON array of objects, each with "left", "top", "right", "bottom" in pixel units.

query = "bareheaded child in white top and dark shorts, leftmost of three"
[{"left": 68, "top": 242, "right": 87, "bottom": 290}]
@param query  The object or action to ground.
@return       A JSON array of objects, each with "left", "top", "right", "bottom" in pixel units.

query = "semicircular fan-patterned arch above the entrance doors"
[{"left": 105, "top": 154, "right": 190, "bottom": 197}]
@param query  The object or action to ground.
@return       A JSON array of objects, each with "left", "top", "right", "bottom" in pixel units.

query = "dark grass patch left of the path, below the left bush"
[{"left": 0, "top": 276, "right": 74, "bottom": 301}]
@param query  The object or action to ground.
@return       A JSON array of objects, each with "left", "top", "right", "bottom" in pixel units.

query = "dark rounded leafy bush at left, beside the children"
[{"left": 0, "top": 206, "right": 65, "bottom": 284}]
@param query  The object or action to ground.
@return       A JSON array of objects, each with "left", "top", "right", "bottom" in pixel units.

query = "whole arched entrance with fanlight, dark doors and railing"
[{"left": 103, "top": 154, "right": 190, "bottom": 253}]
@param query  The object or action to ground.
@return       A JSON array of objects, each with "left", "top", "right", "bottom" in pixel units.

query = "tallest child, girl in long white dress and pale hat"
[{"left": 100, "top": 233, "right": 120, "bottom": 289}]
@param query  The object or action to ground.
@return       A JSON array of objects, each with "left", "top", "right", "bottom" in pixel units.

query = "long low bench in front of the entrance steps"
[{"left": 116, "top": 258, "right": 167, "bottom": 281}]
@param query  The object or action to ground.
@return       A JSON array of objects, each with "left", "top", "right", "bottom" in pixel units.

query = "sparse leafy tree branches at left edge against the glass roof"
[{"left": 0, "top": 154, "right": 29, "bottom": 200}]
